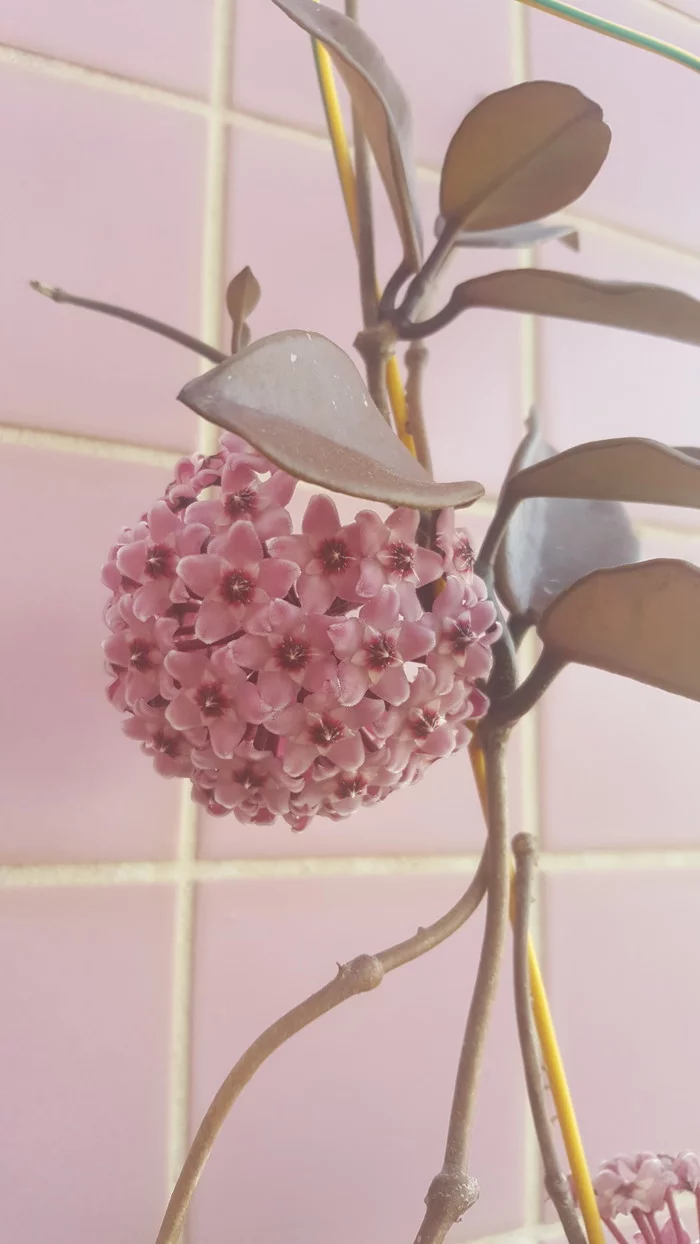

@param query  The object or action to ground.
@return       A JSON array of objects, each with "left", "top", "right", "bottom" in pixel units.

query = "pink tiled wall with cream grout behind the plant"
[{"left": 0, "top": 0, "right": 700, "bottom": 1244}]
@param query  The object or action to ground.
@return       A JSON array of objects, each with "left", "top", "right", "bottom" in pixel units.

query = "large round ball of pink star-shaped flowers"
[{"left": 103, "top": 433, "right": 499, "bottom": 830}]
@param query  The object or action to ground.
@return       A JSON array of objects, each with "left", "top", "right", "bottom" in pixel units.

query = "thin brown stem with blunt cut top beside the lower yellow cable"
[{"left": 512, "top": 833, "right": 586, "bottom": 1244}]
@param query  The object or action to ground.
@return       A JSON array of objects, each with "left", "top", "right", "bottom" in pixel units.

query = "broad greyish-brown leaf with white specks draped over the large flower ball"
[{"left": 179, "top": 331, "right": 484, "bottom": 510}]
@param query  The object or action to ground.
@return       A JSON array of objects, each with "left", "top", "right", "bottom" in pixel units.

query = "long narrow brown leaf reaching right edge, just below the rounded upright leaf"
[{"left": 449, "top": 267, "right": 700, "bottom": 346}]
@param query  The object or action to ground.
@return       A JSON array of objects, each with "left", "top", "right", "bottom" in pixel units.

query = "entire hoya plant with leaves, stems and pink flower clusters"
[{"left": 35, "top": 0, "right": 700, "bottom": 1244}]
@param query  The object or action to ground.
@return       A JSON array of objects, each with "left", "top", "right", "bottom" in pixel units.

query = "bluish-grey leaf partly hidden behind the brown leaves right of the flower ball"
[{"left": 494, "top": 417, "right": 639, "bottom": 620}]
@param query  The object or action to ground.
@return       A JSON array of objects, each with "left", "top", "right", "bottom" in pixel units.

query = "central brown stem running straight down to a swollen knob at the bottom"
[{"left": 415, "top": 725, "right": 509, "bottom": 1244}]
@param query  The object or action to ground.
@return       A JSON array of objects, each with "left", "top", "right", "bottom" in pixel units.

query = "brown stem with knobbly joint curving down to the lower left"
[{"left": 157, "top": 852, "right": 489, "bottom": 1244}]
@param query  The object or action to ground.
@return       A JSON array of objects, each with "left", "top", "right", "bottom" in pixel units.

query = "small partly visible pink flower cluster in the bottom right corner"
[{"left": 593, "top": 1153, "right": 700, "bottom": 1244}]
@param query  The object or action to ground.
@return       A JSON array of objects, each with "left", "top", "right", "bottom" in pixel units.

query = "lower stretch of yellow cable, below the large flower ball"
[{"left": 469, "top": 739, "right": 606, "bottom": 1244}]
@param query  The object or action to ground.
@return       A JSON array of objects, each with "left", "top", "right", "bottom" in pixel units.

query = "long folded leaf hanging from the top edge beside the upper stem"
[{"left": 274, "top": 0, "right": 423, "bottom": 272}]
